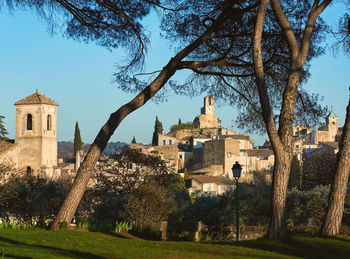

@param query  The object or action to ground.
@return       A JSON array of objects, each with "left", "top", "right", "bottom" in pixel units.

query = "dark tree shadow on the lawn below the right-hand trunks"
[{"left": 211, "top": 236, "right": 350, "bottom": 258}]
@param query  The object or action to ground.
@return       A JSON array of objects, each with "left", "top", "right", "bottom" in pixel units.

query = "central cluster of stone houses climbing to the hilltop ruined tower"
[{"left": 130, "top": 95, "right": 274, "bottom": 195}]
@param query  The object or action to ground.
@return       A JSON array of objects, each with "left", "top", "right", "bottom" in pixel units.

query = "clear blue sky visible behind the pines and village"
[{"left": 0, "top": 3, "right": 350, "bottom": 144}]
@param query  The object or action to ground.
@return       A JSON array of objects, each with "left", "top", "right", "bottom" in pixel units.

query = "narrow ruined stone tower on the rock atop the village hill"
[{"left": 193, "top": 95, "right": 219, "bottom": 129}]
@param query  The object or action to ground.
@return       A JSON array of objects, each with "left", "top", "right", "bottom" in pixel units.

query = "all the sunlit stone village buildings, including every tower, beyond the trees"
[{"left": 0, "top": 91, "right": 342, "bottom": 195}]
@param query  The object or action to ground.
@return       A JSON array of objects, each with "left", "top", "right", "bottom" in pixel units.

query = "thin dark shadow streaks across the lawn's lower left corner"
[{"left": 0, "top": 237, "right": 105, "bottom": 259}]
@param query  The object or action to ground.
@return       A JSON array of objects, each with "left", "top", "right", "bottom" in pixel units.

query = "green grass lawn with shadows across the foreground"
[{"left": 0, "top": 229, "right": 350, "bottom": 258}]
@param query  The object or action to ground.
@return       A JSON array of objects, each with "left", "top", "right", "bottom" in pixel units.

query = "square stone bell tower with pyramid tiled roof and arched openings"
[{"left": 15, "top": 90, "right": 58, "bottom": 176}]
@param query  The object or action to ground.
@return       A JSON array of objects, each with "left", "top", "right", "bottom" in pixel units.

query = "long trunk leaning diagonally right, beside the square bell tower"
[{"left": 51, "top": 11, "right": 225, "bottom": 230}]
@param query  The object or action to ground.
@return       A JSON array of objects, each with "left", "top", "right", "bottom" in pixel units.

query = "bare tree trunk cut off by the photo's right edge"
[{"left": 321, "top": 90, "right": 350, "bottom": 236}]
